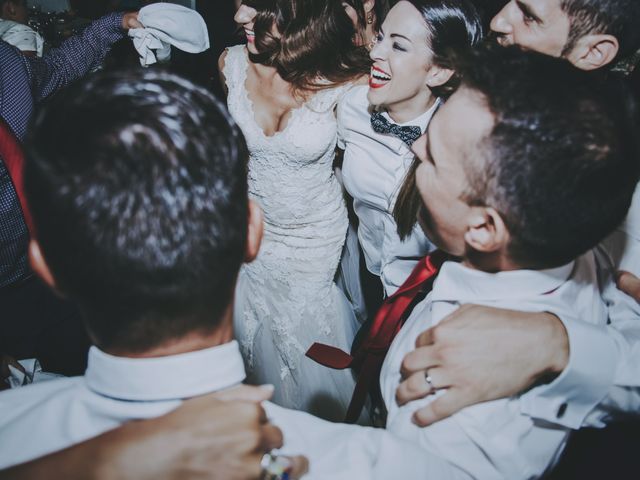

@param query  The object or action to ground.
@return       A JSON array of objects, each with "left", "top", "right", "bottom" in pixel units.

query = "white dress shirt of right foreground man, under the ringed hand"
[{"left": 380, "top": 253, "right": 606, "bottom": 480}]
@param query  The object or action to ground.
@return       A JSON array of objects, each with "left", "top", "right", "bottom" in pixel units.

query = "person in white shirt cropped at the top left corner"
[{"left": 0, "top": 0, "right": 44, "bottom": 57}]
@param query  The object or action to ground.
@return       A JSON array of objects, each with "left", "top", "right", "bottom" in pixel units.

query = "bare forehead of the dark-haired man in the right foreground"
[{"left": 429, "top": 87, "right": 494, "bottom": 164}]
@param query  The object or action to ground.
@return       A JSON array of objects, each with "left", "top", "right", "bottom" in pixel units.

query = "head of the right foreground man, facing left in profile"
[{"left": 414, "top": 46, "right": 639, "bottom": 270}]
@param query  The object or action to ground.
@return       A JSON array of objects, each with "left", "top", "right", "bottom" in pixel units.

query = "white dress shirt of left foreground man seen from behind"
[{"left": 0, "top": 341, "right": 460, "bottom": 480}]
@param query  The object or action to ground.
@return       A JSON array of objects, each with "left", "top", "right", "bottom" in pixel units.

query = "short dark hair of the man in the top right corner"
[{"left": 560, "top": 0, "right": 640, "bottom": 58}]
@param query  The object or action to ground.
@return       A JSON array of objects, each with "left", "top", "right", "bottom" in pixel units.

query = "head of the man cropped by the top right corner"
[{"left": 491, "top": 0, "right": 640, "bottom": 70}]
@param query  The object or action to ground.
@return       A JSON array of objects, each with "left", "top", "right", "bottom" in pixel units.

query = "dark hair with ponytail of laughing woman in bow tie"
[{"left": 393, "top": 0, "right": 482, "bottom": 239}]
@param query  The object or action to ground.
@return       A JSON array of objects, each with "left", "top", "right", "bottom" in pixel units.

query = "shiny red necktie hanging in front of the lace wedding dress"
[{"left": 306, "top": 250, "right": 448, "bottom": 423}]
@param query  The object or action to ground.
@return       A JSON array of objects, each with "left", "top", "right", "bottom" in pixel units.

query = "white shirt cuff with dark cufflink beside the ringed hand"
[{"left": 520, "top": 316, "right": 618, "bottom": 429}]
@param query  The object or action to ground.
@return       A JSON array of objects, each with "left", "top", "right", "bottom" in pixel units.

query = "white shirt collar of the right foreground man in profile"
[{"left": 431, "top": 262, "right": 575, "bottom": 303}]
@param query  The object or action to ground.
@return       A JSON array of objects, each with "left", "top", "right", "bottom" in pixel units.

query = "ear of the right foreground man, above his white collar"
[{"left": 464, "top": 207, "right": 509, "bottom": 253}]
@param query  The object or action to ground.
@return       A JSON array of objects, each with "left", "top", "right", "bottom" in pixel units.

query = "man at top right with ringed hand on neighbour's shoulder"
[{"left": 398, "top": 0, "right": 640, "bottom": 429}]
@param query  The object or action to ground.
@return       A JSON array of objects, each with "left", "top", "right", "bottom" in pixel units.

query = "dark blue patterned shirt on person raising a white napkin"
[{"left": 0, "top": 13, "right": 126, "bottom": 288}]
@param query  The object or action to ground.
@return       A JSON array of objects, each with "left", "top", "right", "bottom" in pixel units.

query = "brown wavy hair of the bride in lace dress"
[{"left": 245, "top": 0, "right": 371, "bottom": 93}]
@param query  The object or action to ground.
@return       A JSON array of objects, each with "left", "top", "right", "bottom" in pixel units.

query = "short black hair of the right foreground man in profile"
[{"left": 460, "top": 45, "right": 640, "bottom": 268}]
